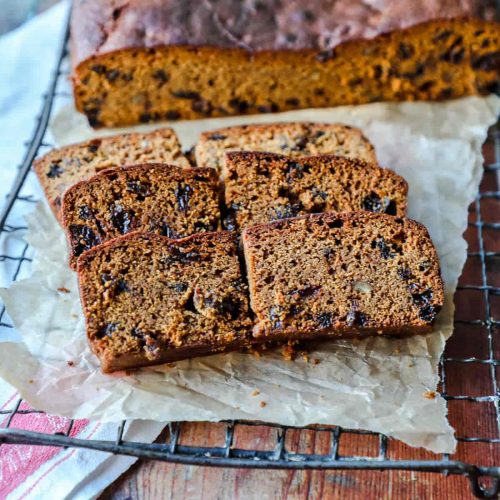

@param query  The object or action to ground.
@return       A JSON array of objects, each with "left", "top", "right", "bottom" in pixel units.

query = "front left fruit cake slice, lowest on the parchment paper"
[{"left": 78, "top": 231, "right": 252, "bottom": 373}]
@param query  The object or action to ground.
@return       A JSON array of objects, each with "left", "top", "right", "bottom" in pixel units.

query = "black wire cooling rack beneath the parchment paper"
[{"left": 0, "top": 4, "right": 500, "bottom": 498}]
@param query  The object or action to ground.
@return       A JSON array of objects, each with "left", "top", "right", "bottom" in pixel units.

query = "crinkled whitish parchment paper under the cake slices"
[{"left": 0, "top": 96, "right": 500, "bottom": 452}]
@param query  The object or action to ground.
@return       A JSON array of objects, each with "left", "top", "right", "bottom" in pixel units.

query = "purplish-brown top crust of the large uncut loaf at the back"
[{"left": 71, "top": 0, "right": 484, "bottom": 66}]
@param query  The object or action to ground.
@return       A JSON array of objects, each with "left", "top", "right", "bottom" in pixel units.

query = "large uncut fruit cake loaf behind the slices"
[{"left": 71, "top": 0, "right": 500, "bottom": 127}]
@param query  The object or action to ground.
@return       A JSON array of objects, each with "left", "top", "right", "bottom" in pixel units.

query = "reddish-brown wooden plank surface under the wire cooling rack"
[{"left": 101, "top": 144, "right": 500, "bottom": 500}]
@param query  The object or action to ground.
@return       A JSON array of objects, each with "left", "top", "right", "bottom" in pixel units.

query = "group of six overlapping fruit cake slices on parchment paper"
[{"left": 32, "top": 123, "right": 444, "bottom": 372}]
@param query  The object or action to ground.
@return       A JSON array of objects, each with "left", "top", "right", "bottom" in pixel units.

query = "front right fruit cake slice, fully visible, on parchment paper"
[{"left": 242, "top": 212, "right": 444, "bottom": 341}]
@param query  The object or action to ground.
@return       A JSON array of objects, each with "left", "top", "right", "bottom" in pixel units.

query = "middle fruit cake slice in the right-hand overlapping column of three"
[{"left": 223, "top": 151, "right": 408, "bottom": 229}]
